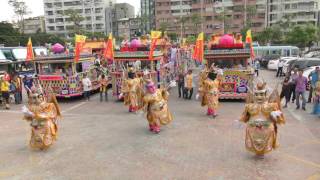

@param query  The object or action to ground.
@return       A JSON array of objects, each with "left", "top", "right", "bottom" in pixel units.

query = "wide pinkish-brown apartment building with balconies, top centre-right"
[{"left": 155, "top": 0, "right": 267, "bottom": 36}]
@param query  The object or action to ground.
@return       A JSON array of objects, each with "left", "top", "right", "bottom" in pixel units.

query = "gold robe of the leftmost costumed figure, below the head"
[{"left": 24, "top": 102, "right": 59, "bottom": 149}]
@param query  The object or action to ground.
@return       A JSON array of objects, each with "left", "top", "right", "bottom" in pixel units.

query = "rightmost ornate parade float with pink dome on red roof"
[{"left": 204, "top": 34, "right": 254, "bottom": 99}]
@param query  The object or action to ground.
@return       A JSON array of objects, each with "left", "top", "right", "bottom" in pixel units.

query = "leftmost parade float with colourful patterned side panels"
[{"left": 33, "top": 48, "right": 107, "bottom": 98}]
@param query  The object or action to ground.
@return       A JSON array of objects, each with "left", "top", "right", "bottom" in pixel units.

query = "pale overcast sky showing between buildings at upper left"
[{"left": 0, "top": 0, "right": 140, "bottom": 21}]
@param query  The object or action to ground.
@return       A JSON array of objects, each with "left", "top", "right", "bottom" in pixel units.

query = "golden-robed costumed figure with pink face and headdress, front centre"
[{"left": 143, "top": 80, "right": 173, "bottom": 133}]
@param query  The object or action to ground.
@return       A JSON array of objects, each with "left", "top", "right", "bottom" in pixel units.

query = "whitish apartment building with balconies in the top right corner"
[{"left": 268, "top": 0, "right": 320, "bottom": 26}]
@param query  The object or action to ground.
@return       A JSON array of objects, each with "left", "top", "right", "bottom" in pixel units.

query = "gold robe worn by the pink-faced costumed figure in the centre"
[{"left": 143, "top": 89, "right": 173, "bottom": 126}]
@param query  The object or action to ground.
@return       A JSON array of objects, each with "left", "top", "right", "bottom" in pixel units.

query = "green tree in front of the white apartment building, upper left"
[{"left": 64, "top": 9, "right": 85, "bottom": 34}]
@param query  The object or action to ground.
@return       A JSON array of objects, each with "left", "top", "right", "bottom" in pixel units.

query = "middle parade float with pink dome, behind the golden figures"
[{"left": 111, "top": 39, "right": 163, "bottom": 100}]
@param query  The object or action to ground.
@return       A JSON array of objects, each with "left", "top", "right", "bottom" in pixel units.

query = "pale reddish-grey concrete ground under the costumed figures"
[{"left": 0, "top": 71, "right": 320, "bottom": 180}]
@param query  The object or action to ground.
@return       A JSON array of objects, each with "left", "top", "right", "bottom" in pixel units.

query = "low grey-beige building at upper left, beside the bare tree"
[{"left": 21, "top": 16, "right": 46, "bottom": 34}]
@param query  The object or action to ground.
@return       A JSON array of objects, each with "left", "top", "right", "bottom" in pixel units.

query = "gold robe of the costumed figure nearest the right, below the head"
[{"left": 240, "top": 102, "right": 285, "bottom": 155}]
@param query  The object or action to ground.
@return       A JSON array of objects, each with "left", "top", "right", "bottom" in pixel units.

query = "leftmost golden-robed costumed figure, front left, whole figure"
[{"left": 23, "top": 89, "right": 61, "bottom": 150}]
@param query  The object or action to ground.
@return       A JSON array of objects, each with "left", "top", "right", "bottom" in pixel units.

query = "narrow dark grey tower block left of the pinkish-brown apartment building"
[{"left": 140, "top": 0, "right": 156, "bottom": 33}]
